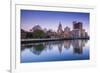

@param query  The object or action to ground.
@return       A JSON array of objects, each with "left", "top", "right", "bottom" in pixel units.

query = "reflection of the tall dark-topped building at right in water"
[{"left": 72, "top": 40, "right": 85, "bottom": 54}]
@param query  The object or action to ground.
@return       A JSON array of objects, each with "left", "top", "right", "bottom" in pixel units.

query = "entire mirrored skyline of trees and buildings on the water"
[{"left": 21, "top": 40, "right": 88, "bottom": 55}]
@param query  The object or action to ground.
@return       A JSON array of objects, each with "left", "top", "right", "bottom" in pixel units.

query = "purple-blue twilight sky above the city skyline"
[{"left": 20, "top": 10, "right": 90, "bottom": 33}]
